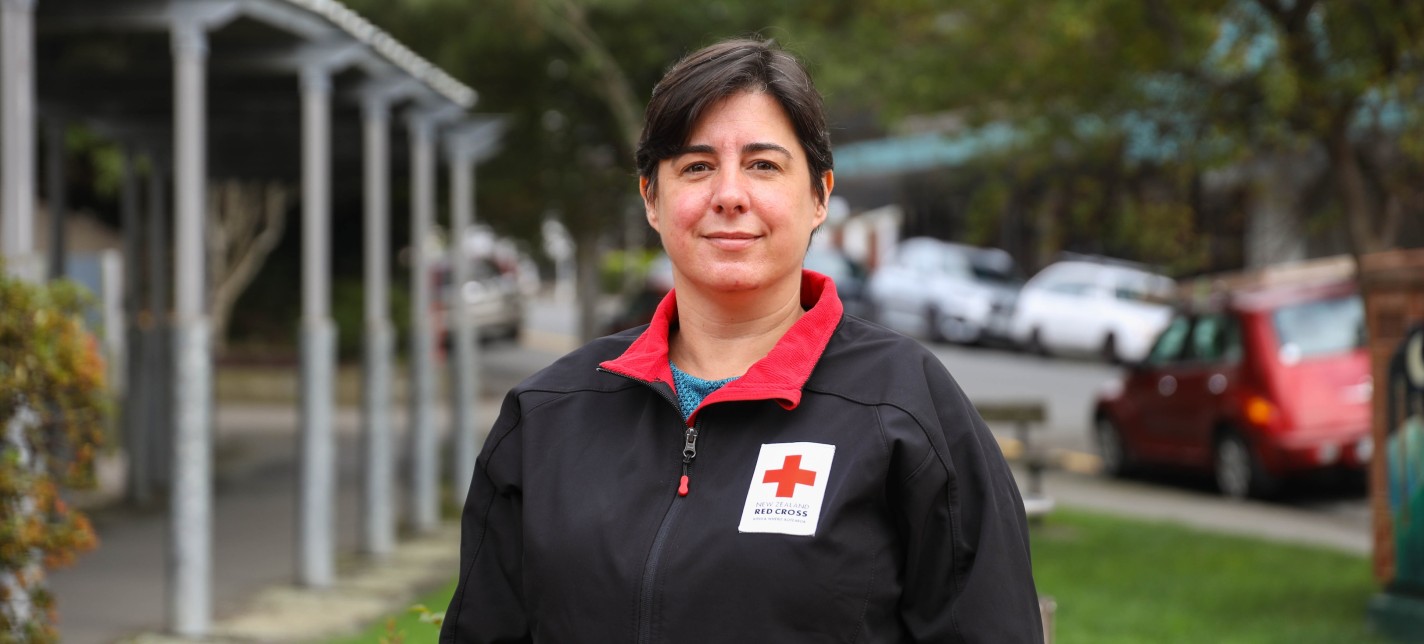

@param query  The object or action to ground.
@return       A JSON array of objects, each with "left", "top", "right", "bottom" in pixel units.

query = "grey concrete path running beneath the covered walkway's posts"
[{"left": 50, "top": 400, "right": 478, "bottom": 644}]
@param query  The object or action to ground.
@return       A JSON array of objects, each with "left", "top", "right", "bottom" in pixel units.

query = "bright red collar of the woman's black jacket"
[{"left": 600, "top": 269, "right": 844, "bottom": 425}]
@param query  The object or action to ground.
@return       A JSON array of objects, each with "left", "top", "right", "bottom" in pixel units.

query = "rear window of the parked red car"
[{"left": 1270, "top": 295, "right": 1364, "bottom": 362}]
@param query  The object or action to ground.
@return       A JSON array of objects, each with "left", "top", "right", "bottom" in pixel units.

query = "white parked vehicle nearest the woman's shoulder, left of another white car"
[{"left": 867, "top": 237, "right": 1022, "bottom": 343}]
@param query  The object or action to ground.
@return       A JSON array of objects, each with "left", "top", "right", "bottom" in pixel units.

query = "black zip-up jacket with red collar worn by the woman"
[{"left": 440, "top": 272, "right": 1042, "bottom": 644}]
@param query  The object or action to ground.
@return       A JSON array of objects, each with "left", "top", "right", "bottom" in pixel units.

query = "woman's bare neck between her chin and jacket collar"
[{"left": 668, "top": 276, "right": 805, "bottom": 380}]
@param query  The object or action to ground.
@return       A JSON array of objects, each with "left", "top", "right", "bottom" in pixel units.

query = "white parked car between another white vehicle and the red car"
[{"left": 1010, "top": 259, "right": 1176, "bottom": 362}]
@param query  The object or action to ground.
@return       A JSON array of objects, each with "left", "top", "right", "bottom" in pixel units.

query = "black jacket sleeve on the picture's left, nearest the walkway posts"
[{"left": 440, "top": 393, "right": 533, "bottom": 644}]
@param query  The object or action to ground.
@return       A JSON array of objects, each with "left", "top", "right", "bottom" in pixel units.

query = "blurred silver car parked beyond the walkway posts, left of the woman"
[{"left": 434, "top": 258, "right": 524, "bottom": 346}]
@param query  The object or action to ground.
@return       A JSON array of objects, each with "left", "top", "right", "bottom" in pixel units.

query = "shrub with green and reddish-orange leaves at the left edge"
[{"left": 0, "top": 262, "right": 108, "bottom": 641}]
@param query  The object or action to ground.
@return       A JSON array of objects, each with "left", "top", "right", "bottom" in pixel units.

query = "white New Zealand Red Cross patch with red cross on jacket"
[{"left": 736, "top": 443, "right": 836, "bottom": 537}]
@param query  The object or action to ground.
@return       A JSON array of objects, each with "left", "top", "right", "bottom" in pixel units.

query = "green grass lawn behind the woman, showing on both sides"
[{"left": 327, "top": 510, "right": 1387, "bottom": 644}]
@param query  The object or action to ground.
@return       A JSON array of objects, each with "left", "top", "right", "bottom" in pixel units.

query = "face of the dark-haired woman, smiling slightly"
[{"left": 641, "top": 93, "right": 833, "bottom": 295}]
